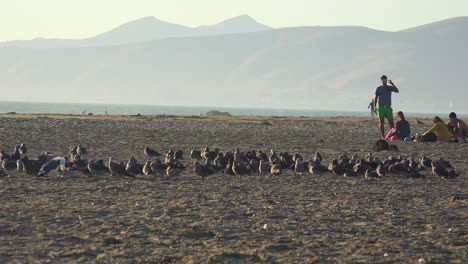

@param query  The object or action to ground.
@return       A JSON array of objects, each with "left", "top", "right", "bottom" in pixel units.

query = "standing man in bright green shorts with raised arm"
[{"left": 374, "top": 75, "right": 400, "bottom": 139}]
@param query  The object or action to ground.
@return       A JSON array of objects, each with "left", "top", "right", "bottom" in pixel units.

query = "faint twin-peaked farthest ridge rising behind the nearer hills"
[{"left": 0, "top": 15, "right": 271, "bottom": 48}]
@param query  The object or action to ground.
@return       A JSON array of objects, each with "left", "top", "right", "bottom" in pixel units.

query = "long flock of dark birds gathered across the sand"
[{"left": 0, "top": 143, "right": 459, "bottom": 179}]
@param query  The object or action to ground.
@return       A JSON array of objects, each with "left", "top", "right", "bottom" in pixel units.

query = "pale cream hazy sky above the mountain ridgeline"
[{"left": 0, "top": 0, "right": 468, "bottom": 41}]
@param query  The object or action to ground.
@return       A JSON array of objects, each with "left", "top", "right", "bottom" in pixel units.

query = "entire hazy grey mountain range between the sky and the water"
[{"left": 0, "top": 16, "right": 468, "bottom": 113}]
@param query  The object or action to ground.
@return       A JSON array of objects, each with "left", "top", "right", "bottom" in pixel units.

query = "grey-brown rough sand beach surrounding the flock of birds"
[{"left": 0, "top": 115, "right": 468, "bottom": 263}]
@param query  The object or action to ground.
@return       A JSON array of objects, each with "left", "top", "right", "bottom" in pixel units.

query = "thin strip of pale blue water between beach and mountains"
[{"left": 0, "top": 102, "right": 460, "bottom": 117}]
